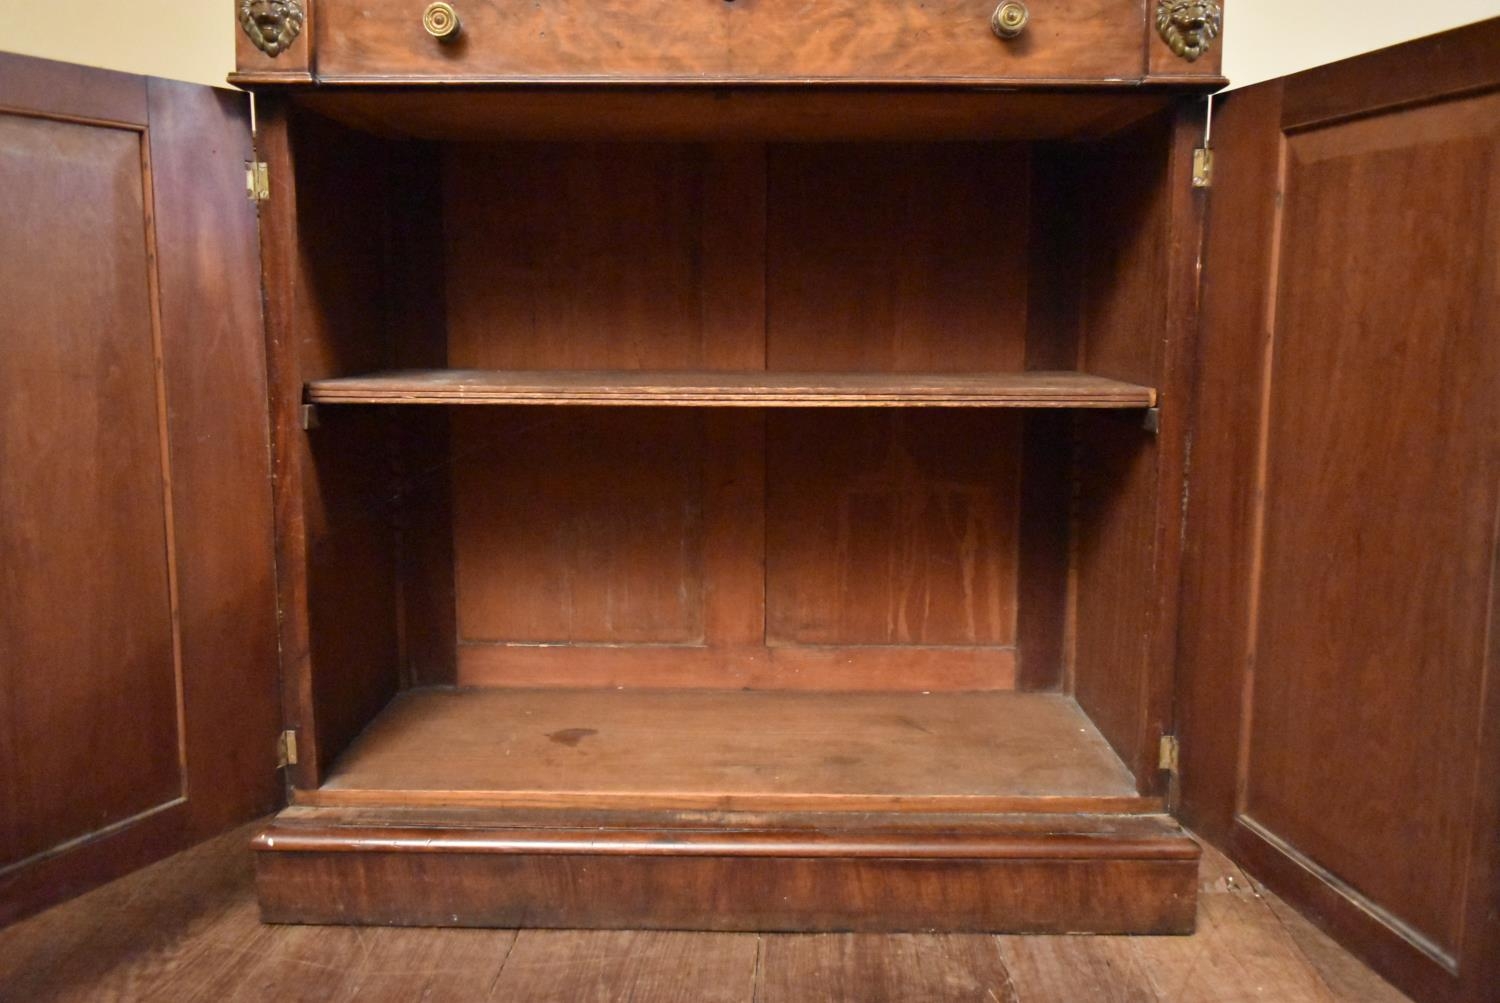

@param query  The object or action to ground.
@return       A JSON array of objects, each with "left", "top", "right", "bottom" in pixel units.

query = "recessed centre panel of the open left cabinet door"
[{"left": 0, "top": 114, "right": 185, "bottom": 870}]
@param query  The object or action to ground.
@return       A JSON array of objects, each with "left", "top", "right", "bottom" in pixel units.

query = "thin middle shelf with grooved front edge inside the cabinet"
[{"left": 308, "top": 369, "right": 1157, "bottom": 408}]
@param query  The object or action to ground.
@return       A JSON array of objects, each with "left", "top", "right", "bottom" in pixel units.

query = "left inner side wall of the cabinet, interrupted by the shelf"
[{"left": 258, "top": 107, "right": 399, "bottom": 787}]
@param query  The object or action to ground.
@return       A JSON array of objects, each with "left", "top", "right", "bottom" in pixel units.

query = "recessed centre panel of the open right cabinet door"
[{"left": 1242, "top": 96, "right": 1500, "bottom": 952}]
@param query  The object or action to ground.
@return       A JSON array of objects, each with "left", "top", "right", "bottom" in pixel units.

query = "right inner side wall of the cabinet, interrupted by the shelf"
[{"left": 1073, "top": 106, "right": 1202, "bottom": 790}]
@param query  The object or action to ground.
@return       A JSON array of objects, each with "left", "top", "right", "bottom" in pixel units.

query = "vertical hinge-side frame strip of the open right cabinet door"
[{"left": 1178, "top": 82, "right": 1281, "bottom": 846}]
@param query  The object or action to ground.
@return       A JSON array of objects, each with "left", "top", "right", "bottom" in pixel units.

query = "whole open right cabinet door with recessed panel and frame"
[{"left": 1179, "top": 21, "right": 1500, "bottom": 1000}]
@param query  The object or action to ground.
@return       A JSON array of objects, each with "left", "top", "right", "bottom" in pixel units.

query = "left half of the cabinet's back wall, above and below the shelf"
[{"left": 446, "top": 144, "right": 765, "bottom": 685}]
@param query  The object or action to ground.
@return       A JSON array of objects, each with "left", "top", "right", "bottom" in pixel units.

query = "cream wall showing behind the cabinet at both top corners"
[{"left": 0, "top": 0, "right": 1500, "bottom": 85}]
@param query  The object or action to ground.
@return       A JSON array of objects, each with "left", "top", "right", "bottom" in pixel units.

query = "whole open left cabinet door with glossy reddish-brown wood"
[{"left": 0, "top": 54, "right": 281, "bottom": 924}]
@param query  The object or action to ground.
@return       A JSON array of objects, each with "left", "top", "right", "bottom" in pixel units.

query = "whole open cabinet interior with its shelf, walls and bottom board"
[{"left": 288, "top": 109, "right": 1176, "bottom": 811}]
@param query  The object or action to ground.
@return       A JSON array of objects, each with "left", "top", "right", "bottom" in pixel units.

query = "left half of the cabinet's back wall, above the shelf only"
[{"left": 438, "top": 142, "right": 765, "bottom": 375}]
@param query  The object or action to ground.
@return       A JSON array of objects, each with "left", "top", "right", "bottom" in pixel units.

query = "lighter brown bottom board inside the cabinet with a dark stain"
[{"left": 297, "top": 688, "right": 1161, "bottom": 813}]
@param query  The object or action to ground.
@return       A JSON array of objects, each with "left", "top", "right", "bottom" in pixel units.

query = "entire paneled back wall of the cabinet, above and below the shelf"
[{"left": 444, "top": 144, "right": 1031, "bottom": 688}]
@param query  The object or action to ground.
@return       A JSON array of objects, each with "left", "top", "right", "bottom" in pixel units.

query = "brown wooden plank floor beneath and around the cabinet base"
[{"left": 0, "top": 828, "right": 1406, "bottom": 1003}]
